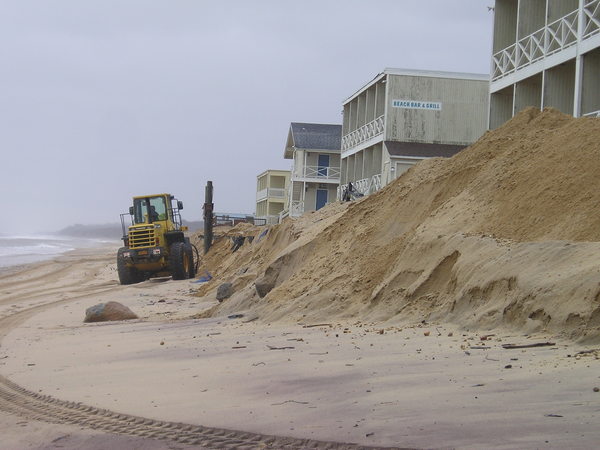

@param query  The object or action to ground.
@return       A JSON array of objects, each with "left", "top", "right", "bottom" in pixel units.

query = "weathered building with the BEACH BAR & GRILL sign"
[{"left": 338, "top": 69, "right": 489, "bottom": 199}]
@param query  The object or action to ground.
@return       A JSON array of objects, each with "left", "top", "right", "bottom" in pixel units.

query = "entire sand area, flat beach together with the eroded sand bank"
[{"left": 0, "top": 109, "right": 600, "bottom": 449}]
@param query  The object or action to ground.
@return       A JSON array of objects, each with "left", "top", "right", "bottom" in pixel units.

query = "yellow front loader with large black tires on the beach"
[{"left": 117, "top": 194, "right": 198, "bottom": 284}]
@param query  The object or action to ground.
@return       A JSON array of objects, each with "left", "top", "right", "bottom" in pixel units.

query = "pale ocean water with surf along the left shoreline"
[{"left": 0, "top": 234, "right": 108, "bottom": 268}]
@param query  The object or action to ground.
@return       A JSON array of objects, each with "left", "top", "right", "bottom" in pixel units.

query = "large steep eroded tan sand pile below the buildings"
[{"left": 193, "top": 109, "right": 600, "bottom": 341}]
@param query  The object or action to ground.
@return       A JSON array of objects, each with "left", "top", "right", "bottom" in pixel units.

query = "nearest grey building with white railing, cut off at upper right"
[{"left": 489, "top": 0, "right": 600, "bottom": 129}]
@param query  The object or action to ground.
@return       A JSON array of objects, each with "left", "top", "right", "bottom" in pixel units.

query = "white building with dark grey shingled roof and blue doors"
[{"left": 283, "top": 122, "right": 342, "bottom": 217}]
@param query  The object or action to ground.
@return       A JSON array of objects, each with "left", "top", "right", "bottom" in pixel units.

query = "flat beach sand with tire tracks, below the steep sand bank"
[{"left": 0, "top": 244, "right": 600, "bottom": 449}]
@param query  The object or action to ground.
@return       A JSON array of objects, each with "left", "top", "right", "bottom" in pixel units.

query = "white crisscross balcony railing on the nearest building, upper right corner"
[{"left": 492, "top": 8, "right": 580, "bottom": 80}]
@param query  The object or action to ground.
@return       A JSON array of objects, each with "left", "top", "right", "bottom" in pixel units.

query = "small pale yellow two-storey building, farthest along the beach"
[{"left": 254, "top": 170, "right": 290, "bottom": 224}]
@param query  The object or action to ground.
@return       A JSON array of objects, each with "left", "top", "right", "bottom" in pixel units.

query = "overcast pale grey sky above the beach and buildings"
[{"left": 0, "top": 0, "right": 493, "bottom": 233}]
